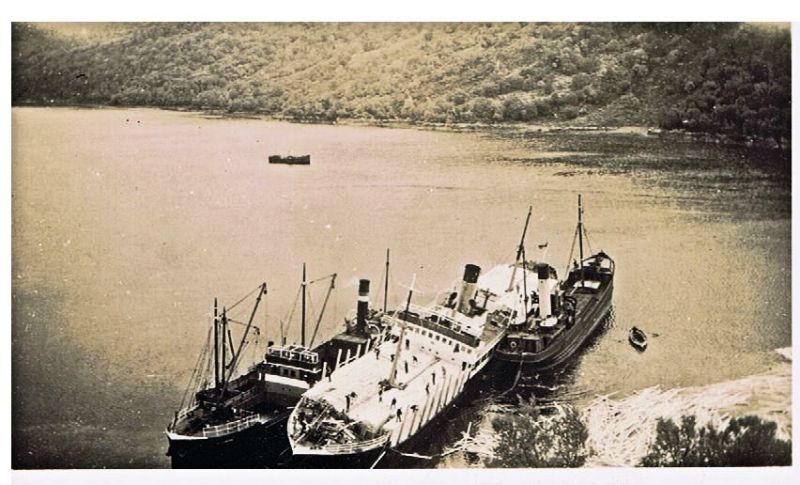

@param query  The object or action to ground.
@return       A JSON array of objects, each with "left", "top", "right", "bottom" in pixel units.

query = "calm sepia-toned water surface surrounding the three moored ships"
[{"left": 12, "top": 108, "right": 791, "bottom": 468}]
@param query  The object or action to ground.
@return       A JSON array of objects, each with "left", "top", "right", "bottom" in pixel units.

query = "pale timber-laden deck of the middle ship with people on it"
[{"left": 294, "top": 266, "right": 523, "bottom": 444}]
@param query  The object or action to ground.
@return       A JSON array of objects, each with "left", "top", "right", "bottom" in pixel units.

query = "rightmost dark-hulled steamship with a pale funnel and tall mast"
[{"left": 495, "top": 196, "right": 615, "bottom": 369}]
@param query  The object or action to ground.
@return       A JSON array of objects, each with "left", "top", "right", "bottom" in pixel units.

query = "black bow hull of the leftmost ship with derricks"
[{"left": 167, "top": 410, "right": 291, "bottom": 468}]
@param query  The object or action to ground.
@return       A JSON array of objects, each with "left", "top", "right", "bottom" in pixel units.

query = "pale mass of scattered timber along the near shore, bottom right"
[{"left": 443, "top": 347, "right": 792, "bottom": 469}]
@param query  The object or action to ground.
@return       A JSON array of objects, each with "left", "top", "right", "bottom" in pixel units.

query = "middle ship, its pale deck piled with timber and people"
[{"left": 287, "top": 255, "right": 540, "bottom": 467}]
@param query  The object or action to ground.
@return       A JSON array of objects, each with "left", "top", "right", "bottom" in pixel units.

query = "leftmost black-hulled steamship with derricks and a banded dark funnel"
[{"left": 166, "top": 265, "right": 388, "bottom": 468}]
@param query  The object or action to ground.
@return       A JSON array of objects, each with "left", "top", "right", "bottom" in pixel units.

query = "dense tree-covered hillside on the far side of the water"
[{"left": 12, "top": 23, "right": 791, "bottom": 143}]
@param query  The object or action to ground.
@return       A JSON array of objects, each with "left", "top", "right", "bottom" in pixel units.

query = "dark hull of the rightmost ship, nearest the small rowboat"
[{"left": 494, "top": 280, "right": 614, "bottom": 370}]
